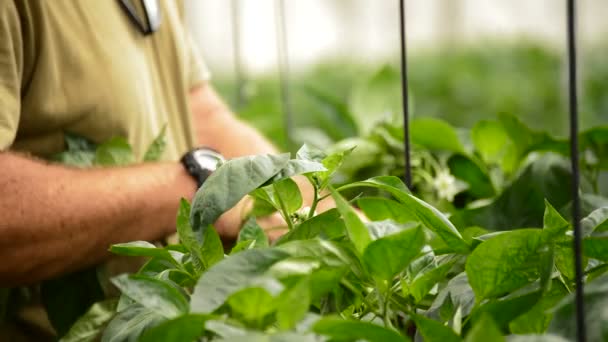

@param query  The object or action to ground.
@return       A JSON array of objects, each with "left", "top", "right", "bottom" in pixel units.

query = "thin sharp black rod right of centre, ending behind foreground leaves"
[{"left": 399, "top": 0, "right": 412, "bottom": 188}]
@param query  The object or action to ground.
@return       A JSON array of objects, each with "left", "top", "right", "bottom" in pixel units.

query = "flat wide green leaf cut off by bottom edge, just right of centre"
[{"left": 313, "top": 317, "right": 409, "bottom": 342}]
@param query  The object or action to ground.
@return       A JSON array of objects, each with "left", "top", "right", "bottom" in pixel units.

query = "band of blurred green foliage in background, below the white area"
[{"left": 214, "top": 41, "right": 608, "bottom": 149}]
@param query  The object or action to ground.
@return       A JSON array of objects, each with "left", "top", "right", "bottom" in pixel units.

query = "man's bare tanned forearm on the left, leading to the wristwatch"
[{"left": 0, "top": 152, "right": 196, "bottom": 286}]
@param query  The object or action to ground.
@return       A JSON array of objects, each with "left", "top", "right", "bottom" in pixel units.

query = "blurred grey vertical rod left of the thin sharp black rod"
[{"left": 275, "top": 0, "right": 293, "bottom": 151}]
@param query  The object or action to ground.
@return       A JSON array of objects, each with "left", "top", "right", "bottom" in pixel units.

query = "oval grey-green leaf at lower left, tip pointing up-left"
[{"left": 112, "top": 274, "right": 188, "bottom": 318}]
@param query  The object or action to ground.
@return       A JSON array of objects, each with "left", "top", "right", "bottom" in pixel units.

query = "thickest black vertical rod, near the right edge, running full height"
[{"left": 567, "top": 0, "right": 587, "bottom": 342}]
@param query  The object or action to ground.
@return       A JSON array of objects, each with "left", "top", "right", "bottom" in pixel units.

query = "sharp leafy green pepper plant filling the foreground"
[{"left": 55, "top": 146, "right": 608, "bottom": 341}]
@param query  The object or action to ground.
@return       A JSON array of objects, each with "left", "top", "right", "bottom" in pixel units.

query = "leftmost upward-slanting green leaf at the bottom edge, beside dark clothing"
[{"left": 59, "top": 299, "right": 117, "bottom": 342}]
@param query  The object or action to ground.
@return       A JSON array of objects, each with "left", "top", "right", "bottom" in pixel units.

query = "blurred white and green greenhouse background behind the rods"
[{"left": 186, "top": 0, "right": 608, "bottom": 149}]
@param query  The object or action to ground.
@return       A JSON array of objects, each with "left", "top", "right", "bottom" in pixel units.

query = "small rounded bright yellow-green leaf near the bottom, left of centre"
[{"left": 227, "top": 287, "right": 276, "bottom": 327}]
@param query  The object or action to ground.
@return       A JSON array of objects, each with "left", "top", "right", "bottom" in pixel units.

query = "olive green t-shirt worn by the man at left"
[{"left": 0, "top": 0, "right": 208, "bottom": 160}]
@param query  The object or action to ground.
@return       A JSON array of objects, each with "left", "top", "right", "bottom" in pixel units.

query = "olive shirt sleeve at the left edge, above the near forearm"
[{"left": 0, "top": 0, "right": 23, "bottom": 151}]
